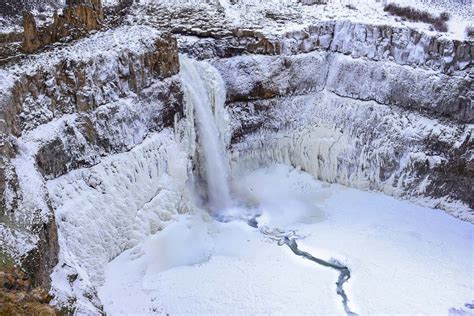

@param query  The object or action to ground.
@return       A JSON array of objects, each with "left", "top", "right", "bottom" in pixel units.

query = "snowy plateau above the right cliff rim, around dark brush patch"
[{"left": 131, "top": 0, "right": 473, "bottom": 40}]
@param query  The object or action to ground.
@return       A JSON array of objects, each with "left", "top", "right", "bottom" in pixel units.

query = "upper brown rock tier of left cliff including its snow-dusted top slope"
[{"left": 0, "top": 28, "right": 179, "bottom": 136}]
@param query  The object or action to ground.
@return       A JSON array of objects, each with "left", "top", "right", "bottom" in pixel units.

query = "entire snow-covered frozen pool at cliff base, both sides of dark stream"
[{"left": 99, "top": 165, "right": 474, "bottom": 315}]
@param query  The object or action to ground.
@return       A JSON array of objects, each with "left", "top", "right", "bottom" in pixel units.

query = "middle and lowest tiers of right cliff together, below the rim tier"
[{"left": 208, "top": 37, "right": 474, "bottom": 221}]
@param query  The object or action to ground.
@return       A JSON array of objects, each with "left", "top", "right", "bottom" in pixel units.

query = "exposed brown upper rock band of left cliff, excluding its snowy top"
[{"left": 6, "top": 33, "right": 179, "bottom": 136}]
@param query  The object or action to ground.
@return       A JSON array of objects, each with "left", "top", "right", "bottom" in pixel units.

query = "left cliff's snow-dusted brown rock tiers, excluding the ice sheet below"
[{"left": 0, "top": 27, "right": 183, "bottom": 295}]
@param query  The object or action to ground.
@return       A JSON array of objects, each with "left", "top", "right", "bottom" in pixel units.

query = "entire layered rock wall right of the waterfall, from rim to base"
[{"left": 174, "top": 11, "right": 474, "bottom": 221}]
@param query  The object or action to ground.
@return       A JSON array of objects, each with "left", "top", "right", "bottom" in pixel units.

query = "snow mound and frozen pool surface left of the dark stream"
[{"left": 99, "top": 214, "right": 343, "bottom": 315}]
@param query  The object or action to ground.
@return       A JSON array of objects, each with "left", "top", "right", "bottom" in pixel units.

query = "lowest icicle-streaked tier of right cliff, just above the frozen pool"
[{"left": 229, "top": 91, "right": 474, "bottom": 222}]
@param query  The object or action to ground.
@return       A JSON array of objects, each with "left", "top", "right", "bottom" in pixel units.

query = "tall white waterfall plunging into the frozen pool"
[{"left": 180, "top": 56, "right": 231, "bottom": 213}]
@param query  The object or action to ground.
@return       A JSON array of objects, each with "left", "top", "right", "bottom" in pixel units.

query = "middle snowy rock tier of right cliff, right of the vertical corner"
[{"left": 326, "top": 55, "right": 474, "bottom": 123}]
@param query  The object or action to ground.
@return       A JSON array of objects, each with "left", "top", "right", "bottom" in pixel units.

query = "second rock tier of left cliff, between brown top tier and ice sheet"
[{"left": 35, "top": 78, "right": 183, "bottom": 179}]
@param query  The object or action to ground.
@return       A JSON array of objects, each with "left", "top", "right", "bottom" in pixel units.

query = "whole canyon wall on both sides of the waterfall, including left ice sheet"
[{"left": 0, "top": 6, "right": 474, "bottom": 313}]
